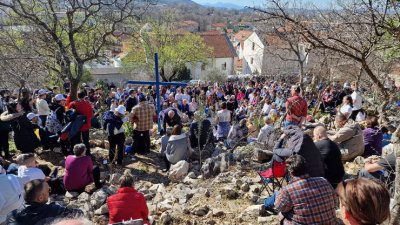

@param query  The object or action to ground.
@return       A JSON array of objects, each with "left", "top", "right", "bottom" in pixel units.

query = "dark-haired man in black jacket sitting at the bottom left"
[{"left": 7, "top": 180, "right": 83, "bottom": 225}]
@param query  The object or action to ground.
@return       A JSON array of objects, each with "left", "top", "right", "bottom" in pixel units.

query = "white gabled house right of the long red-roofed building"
[{"left": 231, "top": 30, "right": 265, "bottom": 74}]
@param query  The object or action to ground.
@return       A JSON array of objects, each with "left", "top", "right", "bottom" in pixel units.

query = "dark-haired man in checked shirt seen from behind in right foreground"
[{"left": 274, "top": 155, "right": 339, "bottom": 225}]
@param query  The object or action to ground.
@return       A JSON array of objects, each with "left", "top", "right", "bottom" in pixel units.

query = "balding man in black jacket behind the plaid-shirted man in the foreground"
[{"left": 314, "top": 126, "right": 344, "bottom": 188}]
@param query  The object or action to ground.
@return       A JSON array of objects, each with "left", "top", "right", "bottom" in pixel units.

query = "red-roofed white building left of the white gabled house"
[{"left": 187, "top": 31, "right": 236, "bottom": 80}]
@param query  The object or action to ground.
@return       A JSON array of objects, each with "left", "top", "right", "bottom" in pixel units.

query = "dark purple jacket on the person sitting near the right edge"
[{"left": 363, "top": 127, "right": 383, "bottom": 157}]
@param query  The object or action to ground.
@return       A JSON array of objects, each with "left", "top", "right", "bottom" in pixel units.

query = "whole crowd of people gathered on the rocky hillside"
[{"left": 0, "top": 77, "right": 399, "bottom": 225}]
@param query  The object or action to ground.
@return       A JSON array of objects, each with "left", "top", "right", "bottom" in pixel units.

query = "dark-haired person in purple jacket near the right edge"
[{"left": 363, "top": 116, "right": 383, "bottom": 158}]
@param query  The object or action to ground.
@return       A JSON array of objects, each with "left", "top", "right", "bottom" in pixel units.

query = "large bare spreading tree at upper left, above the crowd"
[{"left": 0, "top": 0, "right": 153, "bottom": 99}]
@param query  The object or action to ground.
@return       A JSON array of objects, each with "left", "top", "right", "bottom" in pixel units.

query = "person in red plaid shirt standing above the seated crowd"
[{"left": 284, "top": 85, "right": 307, "bottom": 127}]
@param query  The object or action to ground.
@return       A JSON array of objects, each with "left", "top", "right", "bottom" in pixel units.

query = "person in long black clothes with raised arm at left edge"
[{"left": 0, "top": 102, "right": 41, "bottom": 153}]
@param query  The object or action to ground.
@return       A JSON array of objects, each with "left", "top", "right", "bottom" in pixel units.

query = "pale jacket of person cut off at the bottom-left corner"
[{"left": 0, "top": 165, "right": 29, "bottom": 224}]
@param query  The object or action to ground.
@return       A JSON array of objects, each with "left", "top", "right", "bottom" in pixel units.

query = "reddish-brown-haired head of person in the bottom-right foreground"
[{"left": 336, "top": 178, "right": 390, "bottom": 225}]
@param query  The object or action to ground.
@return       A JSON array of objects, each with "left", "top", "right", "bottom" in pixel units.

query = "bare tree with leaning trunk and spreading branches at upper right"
[{"left": 253, "top": 0, "right": 395, "bottom": 113}]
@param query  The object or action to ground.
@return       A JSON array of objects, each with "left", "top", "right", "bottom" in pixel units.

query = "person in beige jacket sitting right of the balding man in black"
[{"left": 328, "top": 113, "right": 364, "bottom": 161}]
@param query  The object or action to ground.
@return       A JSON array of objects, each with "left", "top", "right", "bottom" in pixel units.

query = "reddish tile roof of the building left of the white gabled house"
[{"left": 200, "top": 31, "right": 236, "bottom": 58}]
